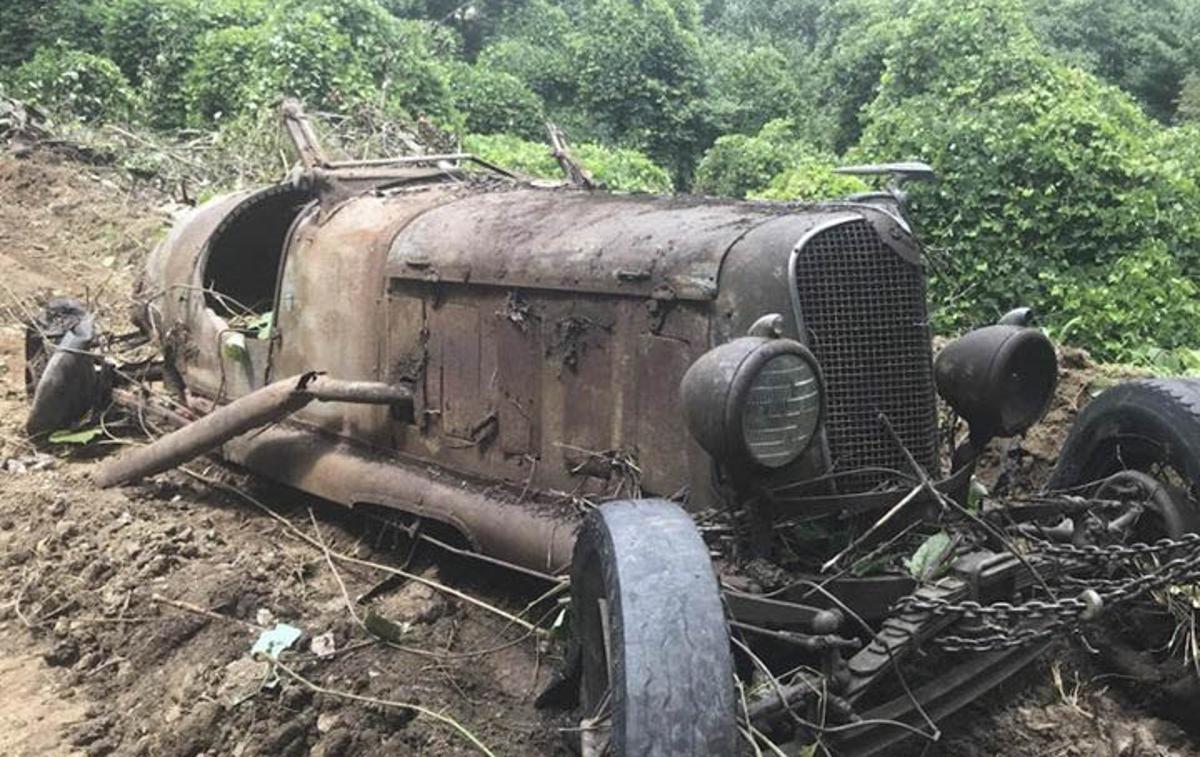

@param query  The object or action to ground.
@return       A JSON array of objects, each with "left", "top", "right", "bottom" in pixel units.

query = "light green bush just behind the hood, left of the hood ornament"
[{"left": 695, "top": 119, "right": 865, "bottom": 200}]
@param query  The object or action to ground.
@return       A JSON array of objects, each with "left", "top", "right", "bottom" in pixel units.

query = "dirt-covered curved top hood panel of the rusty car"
[{"left": 386, "top": 188, "right": 781, "bottom": 300}]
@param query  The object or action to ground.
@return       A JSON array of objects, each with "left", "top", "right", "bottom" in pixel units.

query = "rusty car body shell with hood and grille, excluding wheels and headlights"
[{"left": 133, "top": 175, "right": 955, "bottom": 567}]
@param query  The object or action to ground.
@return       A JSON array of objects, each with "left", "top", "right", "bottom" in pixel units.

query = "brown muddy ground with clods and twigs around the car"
[{"left": 0, "top": 156, "right": 1200, "bottom": 757}]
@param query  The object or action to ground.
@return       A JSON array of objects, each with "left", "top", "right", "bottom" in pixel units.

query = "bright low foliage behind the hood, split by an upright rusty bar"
[{"left": 463, "top": 134, "right": 673, "bottom": 194}]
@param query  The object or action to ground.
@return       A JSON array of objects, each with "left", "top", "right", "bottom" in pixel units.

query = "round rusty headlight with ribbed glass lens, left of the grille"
[{"left": 679, "top": 336, "right": 824, "bottom": 468}]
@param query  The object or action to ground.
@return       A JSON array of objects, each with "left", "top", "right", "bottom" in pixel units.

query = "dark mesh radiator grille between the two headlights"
[{"left": 796, "top": 221, "right": 937, "bottom": 491}]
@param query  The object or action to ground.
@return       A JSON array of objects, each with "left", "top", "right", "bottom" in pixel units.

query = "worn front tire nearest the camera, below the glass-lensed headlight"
[{"left": 571, "top": 499, "right": 737, "bottom": 757}]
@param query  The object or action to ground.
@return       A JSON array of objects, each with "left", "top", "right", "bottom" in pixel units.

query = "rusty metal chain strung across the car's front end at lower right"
[{"left": 898, "top": 534, "right": 1200, "bottom": 651}]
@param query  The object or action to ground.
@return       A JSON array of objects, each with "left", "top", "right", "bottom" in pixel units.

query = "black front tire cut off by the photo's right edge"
[{"left": 1046, "top": 379, "right": 1200, "bottom": 516}]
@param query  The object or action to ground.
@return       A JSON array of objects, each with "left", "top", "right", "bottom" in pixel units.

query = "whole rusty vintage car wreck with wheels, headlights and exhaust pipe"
[{"left": 23, "top": 104, "right": 1200, "bottom": 756}]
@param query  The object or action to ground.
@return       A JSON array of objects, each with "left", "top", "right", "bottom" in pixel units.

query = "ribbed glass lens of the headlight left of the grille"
[{"left": 742, "top": 354, "right": 821, "bottom": 468}]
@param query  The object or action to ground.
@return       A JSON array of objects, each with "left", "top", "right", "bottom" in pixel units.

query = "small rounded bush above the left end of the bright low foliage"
[{"left": 450, "top": 64, "right": 546, "bottom": 138}]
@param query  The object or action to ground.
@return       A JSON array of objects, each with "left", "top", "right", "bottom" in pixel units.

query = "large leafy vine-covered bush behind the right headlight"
[{"left": 858, "top": 0, "right": 1200, "bottom": 359}]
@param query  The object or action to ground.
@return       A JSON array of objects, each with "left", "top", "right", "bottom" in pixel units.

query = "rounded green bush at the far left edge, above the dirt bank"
[{"left": 5, "top": 44, "right": 137, "bottom": 121}]
